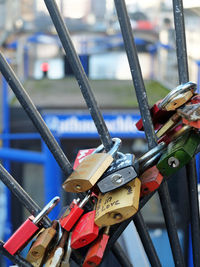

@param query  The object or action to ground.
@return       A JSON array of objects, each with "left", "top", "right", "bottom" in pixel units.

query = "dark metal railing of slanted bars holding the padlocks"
[{"left": 0, "top": 0, "right": 200, "bottom": 267}]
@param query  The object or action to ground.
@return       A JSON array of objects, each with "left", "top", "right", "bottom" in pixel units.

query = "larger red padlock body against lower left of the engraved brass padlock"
[{"left": 71, "top": 210, "right": 99, "bottom": 249}]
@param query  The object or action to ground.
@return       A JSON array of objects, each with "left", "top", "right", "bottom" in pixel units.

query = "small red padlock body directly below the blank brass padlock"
[{"left": 59, "top": 201, "right": 84, "bottom": 232}]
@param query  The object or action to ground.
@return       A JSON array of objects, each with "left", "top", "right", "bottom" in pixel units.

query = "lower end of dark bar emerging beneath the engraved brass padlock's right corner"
[{"left": 133, "top": 212, "right": 162, "bottom": 267}]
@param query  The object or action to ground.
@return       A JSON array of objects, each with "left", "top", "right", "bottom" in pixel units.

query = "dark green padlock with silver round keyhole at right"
[{"left": 156, "top": 131, "right": 200, "bottom": 177}]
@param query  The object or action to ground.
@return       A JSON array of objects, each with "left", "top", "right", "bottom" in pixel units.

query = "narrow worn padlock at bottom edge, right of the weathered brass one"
[{"left": 45, "top": 231, "right": 68, "bottom": 267}]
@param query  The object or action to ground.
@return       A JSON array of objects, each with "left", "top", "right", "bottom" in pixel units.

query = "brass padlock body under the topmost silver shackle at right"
[{"left": 162, "top": 91, "right": 194, "bottom": 111}]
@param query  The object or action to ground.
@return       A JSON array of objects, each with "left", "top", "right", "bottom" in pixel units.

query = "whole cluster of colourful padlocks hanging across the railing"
[{"left": 4, "top": 82, "right": 200, "bottom": 267}]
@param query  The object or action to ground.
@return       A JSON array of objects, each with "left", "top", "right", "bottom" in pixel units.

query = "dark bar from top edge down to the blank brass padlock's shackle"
[{"left": 44, "top": 0, "right": 112, "bottom": 151}]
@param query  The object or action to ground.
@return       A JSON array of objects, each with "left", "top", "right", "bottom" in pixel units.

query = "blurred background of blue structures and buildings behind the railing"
[{"left": 0, "top": 0, "right": 200, "bottom": 266}]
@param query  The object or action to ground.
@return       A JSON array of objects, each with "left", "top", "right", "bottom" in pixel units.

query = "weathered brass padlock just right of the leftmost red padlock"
[{"left": 26, "top": 221, "right": 58, "bottom": 267}]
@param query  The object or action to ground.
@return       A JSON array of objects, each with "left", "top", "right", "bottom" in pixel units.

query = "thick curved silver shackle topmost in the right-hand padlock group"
[{"left": 158, "top": 82, "right": 197, "bottom": 109}]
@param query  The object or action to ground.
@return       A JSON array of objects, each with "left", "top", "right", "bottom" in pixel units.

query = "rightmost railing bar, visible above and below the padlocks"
[{"left": 173, "top": 0, "right": 200, "bottom": 266}]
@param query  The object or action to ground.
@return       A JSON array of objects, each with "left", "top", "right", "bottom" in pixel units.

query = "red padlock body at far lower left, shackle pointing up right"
[{"left": 3, "top": 216, "right": 39, "bottom": 255}]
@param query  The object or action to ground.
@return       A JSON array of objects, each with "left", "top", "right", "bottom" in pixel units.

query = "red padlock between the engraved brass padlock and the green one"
[{"left": 140, "top": 166, "right": 163, "bottom": 197}]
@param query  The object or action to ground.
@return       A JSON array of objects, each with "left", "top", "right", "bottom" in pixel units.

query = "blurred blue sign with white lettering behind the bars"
[{"left": 43, "top": 112, "right": 144, "bottom": 138}]
